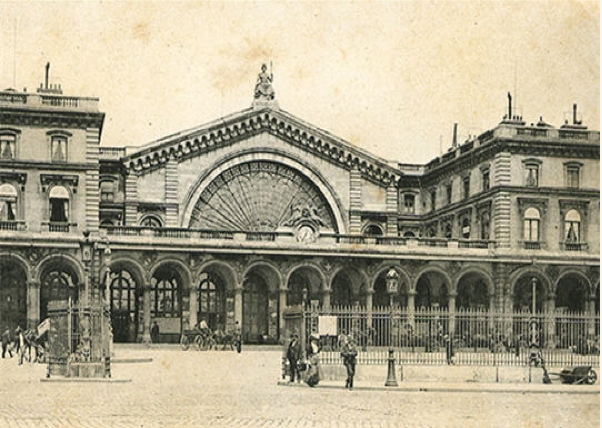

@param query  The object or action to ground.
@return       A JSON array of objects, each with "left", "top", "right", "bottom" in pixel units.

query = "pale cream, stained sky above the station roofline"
[{"left": 0, "top": 0, "right": 600, "bottom": 163}]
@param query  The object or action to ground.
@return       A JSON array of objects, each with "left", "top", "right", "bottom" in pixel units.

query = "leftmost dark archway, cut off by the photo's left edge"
[{"left": 0, "top": 260, "right": 27, "bottom": 331}]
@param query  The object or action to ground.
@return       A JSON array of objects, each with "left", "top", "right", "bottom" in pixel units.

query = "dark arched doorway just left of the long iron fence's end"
[{"left": 242, "top": 265, "right": 279, "bottom": 343}]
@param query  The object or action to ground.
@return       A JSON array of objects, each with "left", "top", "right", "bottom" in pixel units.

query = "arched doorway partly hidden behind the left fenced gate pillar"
[{"left": 40, "top": 262, "right": 79, "bottom": 320}]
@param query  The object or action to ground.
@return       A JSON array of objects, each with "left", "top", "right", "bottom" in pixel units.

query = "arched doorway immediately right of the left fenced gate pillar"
[{"left": 109, "top": 268, "right": 142, "bottom": 343}]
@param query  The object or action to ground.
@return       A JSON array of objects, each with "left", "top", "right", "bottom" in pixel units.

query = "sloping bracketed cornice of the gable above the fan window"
[{"left": 123, "top": 107, "right": 402, "bottom": 186}]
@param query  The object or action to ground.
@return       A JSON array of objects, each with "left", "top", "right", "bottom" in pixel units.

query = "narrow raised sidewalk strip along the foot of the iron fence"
[{"left": 278, "top": 379, "right": 600, "bottom": 394}]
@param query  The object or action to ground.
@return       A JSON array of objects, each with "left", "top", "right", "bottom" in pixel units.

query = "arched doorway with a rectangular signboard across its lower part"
[{"left": 150, "top": 263, "right": 184, "bottom": 342}]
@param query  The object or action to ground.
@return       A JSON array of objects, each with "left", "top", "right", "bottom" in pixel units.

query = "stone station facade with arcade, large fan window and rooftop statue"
[{"left": 0, "top": 70, "right": 600, "bottom": 343}]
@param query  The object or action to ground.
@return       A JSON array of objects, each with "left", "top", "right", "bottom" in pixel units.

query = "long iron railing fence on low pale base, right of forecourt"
[{"left": 304, "top": 306, "right": 600, "bottom": 367}]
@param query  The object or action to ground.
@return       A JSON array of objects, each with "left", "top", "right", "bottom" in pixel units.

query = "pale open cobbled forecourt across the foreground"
[{"left": 0, "top": 347, "right": 600, "bottom": 428}]
